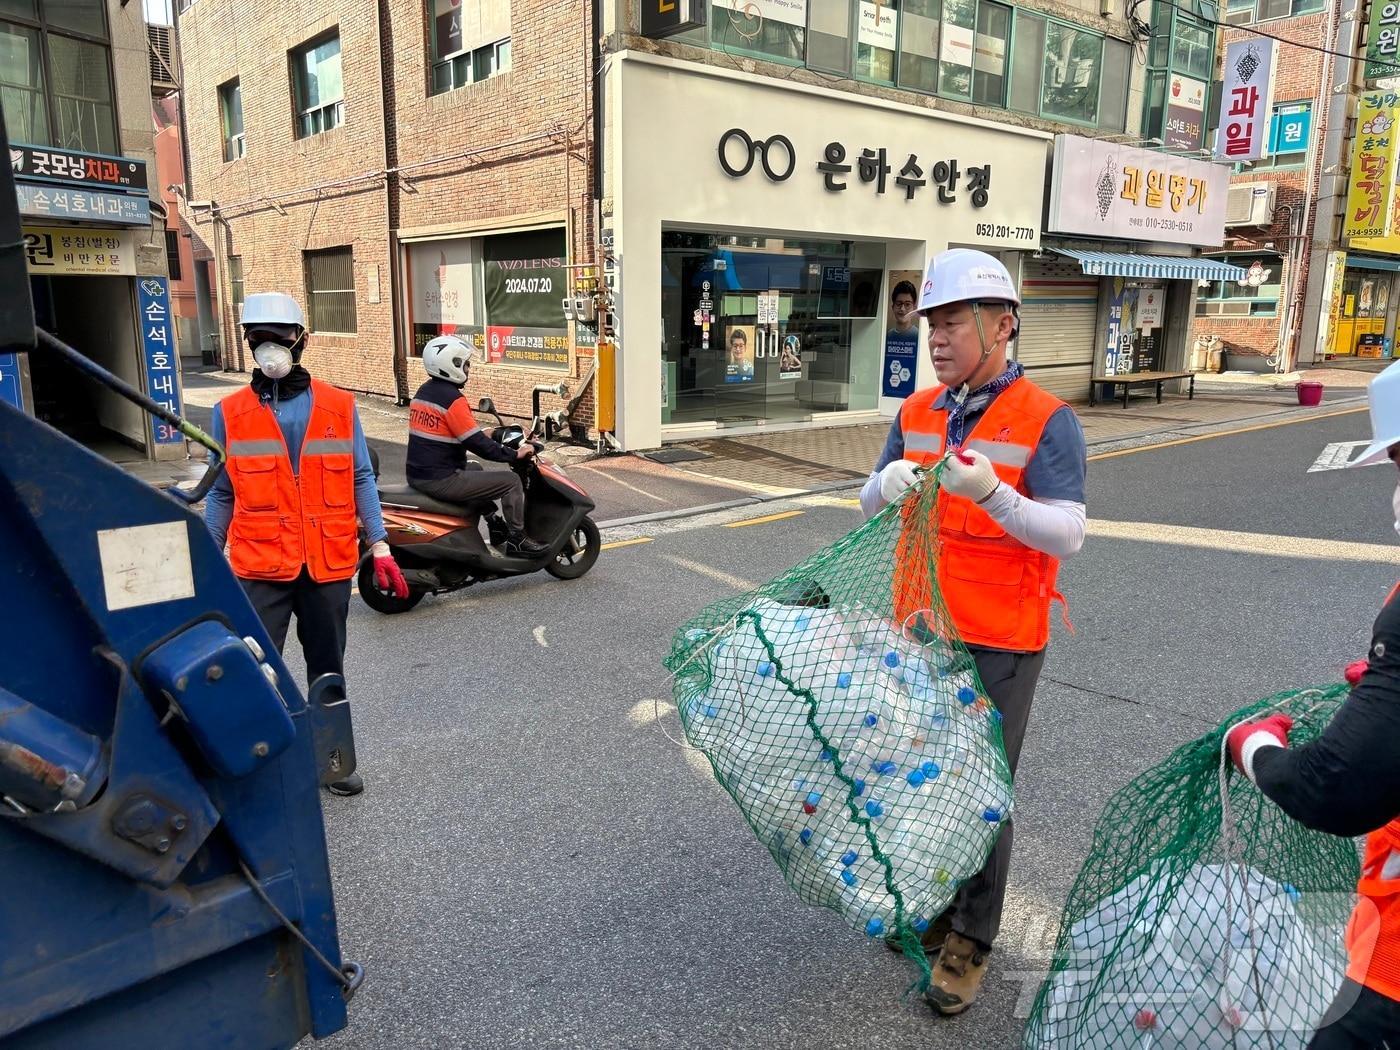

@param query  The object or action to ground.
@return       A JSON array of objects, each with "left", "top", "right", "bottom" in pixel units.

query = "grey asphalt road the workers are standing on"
[{"left": 288, "top": 413, "right": 1400, "bottom": 1050}]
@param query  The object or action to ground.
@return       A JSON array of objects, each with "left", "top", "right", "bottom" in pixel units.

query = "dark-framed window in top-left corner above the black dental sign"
[{"left": 0, "top": 0, "right": 119, "bottom": 154}]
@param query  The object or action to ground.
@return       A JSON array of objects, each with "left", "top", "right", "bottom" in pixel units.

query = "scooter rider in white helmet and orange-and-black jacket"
[{"left": 405, "top": 336, "right": 549, "bottom": 557}]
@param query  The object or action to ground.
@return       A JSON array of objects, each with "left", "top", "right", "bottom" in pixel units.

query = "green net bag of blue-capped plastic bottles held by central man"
[{"left": 666, "top": 469, "right": 1012, "bottom": 987}]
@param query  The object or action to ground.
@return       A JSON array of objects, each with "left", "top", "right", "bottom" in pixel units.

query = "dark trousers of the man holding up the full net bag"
[{"left": 949, "top": 647, "right": 1047, "bottom": 952}]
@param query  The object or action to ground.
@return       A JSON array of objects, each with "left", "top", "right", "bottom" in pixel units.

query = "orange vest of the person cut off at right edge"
[{"left": 1347, "top": 585, "right": 1400, "bottom": 1001}]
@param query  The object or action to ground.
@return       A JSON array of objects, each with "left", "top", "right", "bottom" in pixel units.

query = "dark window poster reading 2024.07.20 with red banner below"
[{"left": 482, "top": 230, "right": 568, "bottom": 370}]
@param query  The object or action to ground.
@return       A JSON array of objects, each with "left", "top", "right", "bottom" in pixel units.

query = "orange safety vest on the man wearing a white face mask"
[{"left": 220, "top": 379, "right": 360, "bottom": 584}]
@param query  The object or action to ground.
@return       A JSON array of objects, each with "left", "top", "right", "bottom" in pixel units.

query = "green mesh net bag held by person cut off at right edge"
[{"left": 1023, "top": 685, "right": 1359, "bottom": 1050}]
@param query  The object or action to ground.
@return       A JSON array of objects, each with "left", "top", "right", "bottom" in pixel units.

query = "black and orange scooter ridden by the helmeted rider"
[{"left": 360, "top": 398, "right": 602, "bottom": 615}]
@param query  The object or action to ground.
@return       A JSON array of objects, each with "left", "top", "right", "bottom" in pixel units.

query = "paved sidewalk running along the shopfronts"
[{"left": 153, "top": 361, "right": 1366, "bottom": 525}]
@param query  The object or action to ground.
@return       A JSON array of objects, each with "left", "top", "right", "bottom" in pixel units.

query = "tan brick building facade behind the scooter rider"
[{"left": 179, "top": 0, "right": 594, "bottom": 431}]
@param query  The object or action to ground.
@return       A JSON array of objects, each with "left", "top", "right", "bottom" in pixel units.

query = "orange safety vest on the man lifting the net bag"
[{"left": 895, "top": 378, "right": 1064, "bottom": 652}]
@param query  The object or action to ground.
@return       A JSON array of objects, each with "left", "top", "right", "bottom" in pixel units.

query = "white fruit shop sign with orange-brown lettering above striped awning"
[{"left": 1046, "top": 134, "right": 1229, "bottom": 248}]
